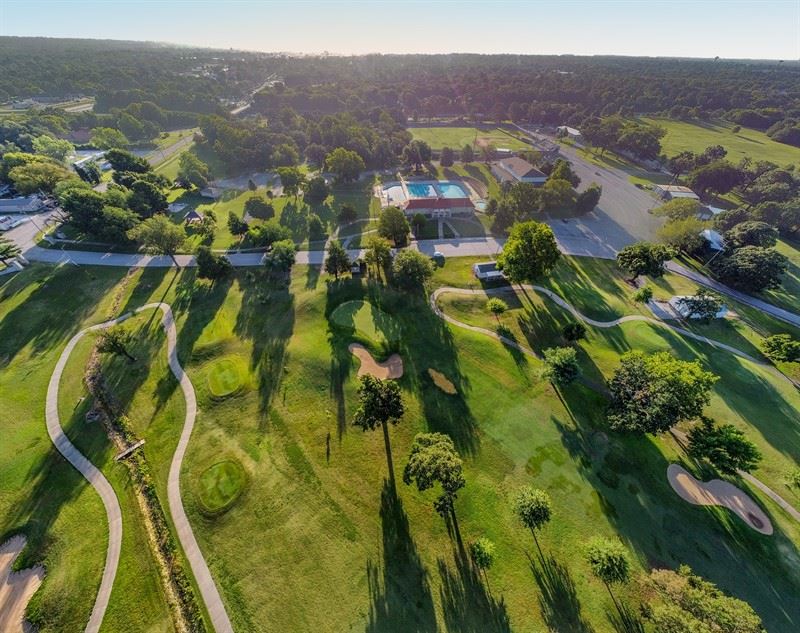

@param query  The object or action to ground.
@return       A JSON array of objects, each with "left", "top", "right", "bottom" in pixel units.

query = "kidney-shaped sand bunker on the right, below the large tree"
[{"left": 667, "top": 464, "right": 772, "bottom": 535}]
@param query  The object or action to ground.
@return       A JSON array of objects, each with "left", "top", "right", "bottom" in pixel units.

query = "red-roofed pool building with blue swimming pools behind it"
[{"left": 381, "top": 180, "right": 475, "bottom": 218}]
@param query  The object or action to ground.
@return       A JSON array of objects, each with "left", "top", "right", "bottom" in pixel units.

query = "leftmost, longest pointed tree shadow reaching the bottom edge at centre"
[{"left": 366, "top": 480, "right": 438, "bottom": 633}]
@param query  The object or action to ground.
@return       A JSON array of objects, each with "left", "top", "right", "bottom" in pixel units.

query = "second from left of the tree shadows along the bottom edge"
[{"left": 438, "top": 547, "right": 511, "bottom": 633}]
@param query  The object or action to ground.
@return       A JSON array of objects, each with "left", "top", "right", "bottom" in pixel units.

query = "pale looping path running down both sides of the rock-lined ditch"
[{"left": 45, "top": 303, "right": 233, "bottom": 633}]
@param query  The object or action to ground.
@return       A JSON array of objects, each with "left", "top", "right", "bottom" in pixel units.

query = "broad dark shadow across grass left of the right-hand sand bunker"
[{"left": 554, "top": 378, "right": 800, "bottom": 630}]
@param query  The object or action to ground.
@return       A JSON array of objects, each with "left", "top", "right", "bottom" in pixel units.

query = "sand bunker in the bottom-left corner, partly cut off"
[{"left": 0, "top": 535, "right": 44, "bottom": 633}]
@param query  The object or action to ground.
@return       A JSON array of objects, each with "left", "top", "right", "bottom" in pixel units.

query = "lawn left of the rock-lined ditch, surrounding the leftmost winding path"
[{"left": 0, "top": 265, "right": 173, "bottom": 633}]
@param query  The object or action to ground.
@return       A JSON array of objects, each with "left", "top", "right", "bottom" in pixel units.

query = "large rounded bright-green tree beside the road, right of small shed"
[{"left": 497, "top": 221, "right": 561, "bottom": 283}]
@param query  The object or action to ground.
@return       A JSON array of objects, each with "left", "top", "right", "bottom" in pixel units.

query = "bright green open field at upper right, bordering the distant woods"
[{"left": 642, "top": 117, "right": 800, "bottom": 166}]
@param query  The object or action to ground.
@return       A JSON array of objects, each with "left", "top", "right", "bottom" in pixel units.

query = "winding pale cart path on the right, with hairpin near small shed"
[{"left": 430, "top": 284, "right": 800, "bottom": 522}]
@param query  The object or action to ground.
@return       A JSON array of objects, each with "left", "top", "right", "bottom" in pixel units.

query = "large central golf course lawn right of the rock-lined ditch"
[{"left": 6, "top": 258, "right": 800, "bottom": 633}]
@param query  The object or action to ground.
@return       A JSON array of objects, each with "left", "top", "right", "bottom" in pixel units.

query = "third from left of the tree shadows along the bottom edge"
[{"left": 528, "top": 555, "right": 594, "bottom": 633}]
